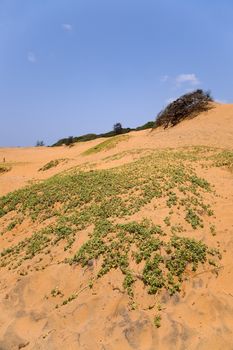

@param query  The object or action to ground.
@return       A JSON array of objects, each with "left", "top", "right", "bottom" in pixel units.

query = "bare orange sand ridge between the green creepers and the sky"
[{"left": 0, "top": 105, "right": 233, "bottom": 195}]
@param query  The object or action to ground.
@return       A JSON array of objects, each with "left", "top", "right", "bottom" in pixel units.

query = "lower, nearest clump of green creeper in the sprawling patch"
[{"left": 69, "top": 220, "right": 220, "bottom": 297}]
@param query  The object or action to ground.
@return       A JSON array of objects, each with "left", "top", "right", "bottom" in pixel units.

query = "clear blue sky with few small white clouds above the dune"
[{"left": 0, "top": 0, "right": 233, "bottom": 146}]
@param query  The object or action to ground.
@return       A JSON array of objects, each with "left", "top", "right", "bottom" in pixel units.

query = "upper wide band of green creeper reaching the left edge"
[{"left": 0, "top": 150, "right": 215, "bottom": 226}]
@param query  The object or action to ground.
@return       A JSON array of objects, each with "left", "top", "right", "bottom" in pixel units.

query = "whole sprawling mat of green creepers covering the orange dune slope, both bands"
[{"left": 0, "top": 146, "right": 231, "bottom": 327}]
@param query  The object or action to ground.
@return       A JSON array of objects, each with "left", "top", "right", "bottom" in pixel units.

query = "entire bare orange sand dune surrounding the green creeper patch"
[{"left": 0, "top": 105, "right": 233, "bottom": 350}]
